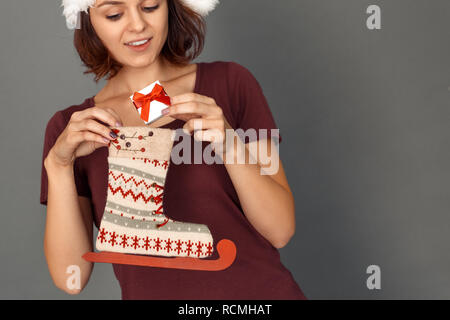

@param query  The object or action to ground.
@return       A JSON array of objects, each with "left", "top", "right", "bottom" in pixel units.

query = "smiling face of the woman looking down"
[{"left": 89, "top": 0, "right": 169, "bottom": 68}]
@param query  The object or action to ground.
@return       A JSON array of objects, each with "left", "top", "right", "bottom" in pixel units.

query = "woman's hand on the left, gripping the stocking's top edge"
[{"left": 49, "top": 107, "right": 122, "bottom": 166}]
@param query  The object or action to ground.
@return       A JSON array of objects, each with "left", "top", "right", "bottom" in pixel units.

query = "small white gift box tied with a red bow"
[{"left": 130, "top": 81, "right": 170, "bottom": 124}]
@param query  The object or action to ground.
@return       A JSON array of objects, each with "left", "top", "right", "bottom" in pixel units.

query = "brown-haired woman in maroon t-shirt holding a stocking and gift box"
[{"left": 41, "top": 0, "right": 306, "bottom": 299}]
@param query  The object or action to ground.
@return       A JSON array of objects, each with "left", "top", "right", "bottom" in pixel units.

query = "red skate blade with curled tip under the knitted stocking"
[{"left": 83, "top": 239, "right": 236, "bottom": 271}]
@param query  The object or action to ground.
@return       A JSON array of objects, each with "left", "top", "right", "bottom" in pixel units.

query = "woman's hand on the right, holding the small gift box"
[{"left": 163, "top": 93, "right": 233, "bottom": 151}]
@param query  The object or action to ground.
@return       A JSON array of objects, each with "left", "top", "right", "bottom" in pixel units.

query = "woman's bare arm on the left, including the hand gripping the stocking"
[{"left": 43, "top": 107, "right": 120, "bottom": 294}]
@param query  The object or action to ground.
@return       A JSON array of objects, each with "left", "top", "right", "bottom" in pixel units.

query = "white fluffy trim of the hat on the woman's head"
[{"left": 62, "top": 0, "right": 219, "bottom": 29}]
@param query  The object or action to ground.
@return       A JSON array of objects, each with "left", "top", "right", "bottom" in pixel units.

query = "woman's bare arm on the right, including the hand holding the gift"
[{"left": 165, "top": 93, "right": 295, "bottom": 248}]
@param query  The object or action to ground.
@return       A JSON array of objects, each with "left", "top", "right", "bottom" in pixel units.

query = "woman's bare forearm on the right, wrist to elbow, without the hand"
[{"left": 224, "top": 132, "right": 295, "bottom": 248}]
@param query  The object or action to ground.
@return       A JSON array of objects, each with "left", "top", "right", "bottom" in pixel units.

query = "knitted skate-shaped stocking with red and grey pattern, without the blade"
[{"left": 96, "top": 126, "right": 213, "bottom": 258}]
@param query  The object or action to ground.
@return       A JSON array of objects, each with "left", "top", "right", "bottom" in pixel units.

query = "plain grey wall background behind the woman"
[{"left": 0, "top": 0, "right": 450, "bottom": 299}]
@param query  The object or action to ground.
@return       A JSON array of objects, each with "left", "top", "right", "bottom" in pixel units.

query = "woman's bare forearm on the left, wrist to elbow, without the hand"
[{"left": 44, "top": 151, "right": 93, "bottom": 294}]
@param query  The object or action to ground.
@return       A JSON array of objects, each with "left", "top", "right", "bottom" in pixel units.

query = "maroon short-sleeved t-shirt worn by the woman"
[{"left": 40, "top": 61, "right": 306, "bottom": 300}]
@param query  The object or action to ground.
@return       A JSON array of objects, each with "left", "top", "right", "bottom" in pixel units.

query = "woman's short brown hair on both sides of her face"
[{"left": 73, "top": 0, "right": 206, "bottom": 82}]
